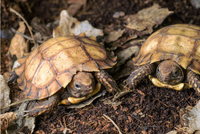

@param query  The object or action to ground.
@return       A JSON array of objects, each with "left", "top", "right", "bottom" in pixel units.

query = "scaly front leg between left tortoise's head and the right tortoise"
[{"left": 95, "top": 70, "right": 120, "bottom": 92}]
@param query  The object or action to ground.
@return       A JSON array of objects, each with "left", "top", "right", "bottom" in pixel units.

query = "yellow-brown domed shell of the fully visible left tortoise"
[{"left": 15, "top": 35, "right": 116, "bottom": 99}]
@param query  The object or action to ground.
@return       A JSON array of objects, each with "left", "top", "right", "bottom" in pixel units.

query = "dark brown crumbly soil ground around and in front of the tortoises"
[{"left": 1, "top": 0, "right": 200, "bottom": 134}]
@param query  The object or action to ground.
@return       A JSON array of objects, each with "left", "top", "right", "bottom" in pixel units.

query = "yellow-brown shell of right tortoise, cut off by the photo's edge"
[{"left": 133, "top": 24, "right": 200, "bottom": 74}]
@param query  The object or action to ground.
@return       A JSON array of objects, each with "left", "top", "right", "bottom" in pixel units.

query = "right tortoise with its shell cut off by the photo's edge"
[{"left": 126, "top": 24, "right": 200, "bottom": 95}]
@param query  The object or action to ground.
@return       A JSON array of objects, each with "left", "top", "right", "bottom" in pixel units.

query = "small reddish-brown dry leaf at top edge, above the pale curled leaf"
[{"left": 67, "top": 0, "right": 87, "bottom": 16}]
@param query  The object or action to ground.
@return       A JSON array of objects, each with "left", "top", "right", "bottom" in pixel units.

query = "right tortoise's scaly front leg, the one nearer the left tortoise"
[{"left": 126, "top": 64, "right": 155, "bottom": 89}]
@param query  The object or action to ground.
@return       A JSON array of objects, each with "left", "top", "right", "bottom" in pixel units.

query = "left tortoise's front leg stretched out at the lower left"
[{"left": 25, "top": 94, "right": 60, "bottom": 117}]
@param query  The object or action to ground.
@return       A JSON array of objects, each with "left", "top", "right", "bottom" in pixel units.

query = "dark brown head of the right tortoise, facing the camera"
[{"left": 156, "top": 60, "right": 184, "bottom": 85}]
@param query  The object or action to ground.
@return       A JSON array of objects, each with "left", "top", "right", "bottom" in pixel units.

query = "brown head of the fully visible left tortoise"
[{"left": 68, "top": 72, "right": 95, "bottom": 98}]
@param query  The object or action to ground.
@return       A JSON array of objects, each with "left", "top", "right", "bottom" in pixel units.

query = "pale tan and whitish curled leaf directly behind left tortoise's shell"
[{"left": 53, "top": 10, "right": 103, "bottom": 38}]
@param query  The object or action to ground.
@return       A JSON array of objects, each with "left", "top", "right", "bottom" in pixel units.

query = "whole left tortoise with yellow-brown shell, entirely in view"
[{"left": 9, "top": 34, "right": 119, "bottom": 116}]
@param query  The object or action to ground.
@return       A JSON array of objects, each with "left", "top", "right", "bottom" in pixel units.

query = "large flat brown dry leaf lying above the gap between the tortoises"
[{"left": 125, "top": 4, "right": 173, "bottom": 34}]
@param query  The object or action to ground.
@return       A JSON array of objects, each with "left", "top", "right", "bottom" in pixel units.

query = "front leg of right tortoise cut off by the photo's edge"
[{"left": 187, "top": 71, "right": 200, "bottom": 96}]
